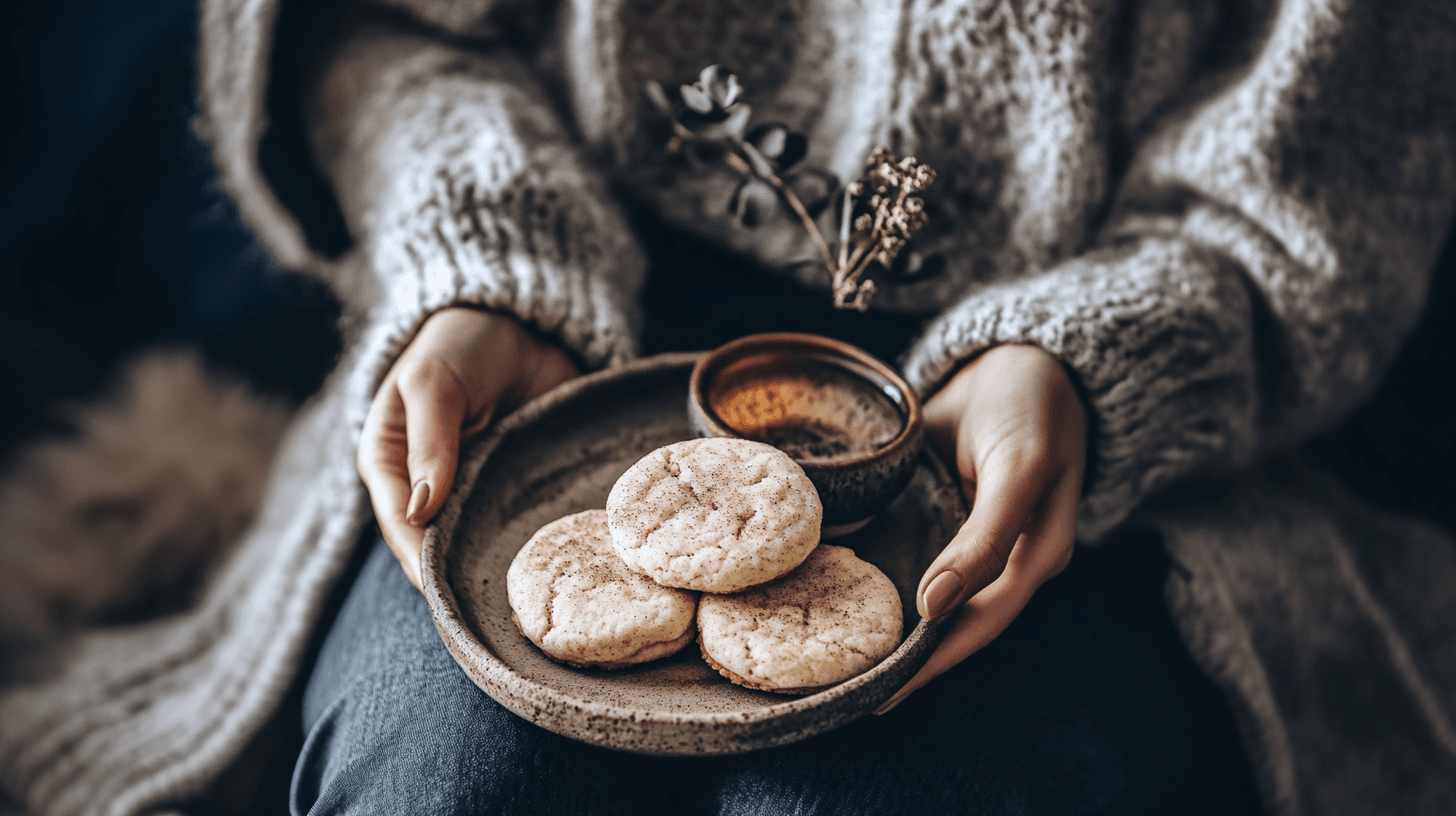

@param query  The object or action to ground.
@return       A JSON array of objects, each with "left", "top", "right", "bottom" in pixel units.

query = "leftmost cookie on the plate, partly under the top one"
[{"left": 505, "top": 510, "right": 697, "bottom": 669}]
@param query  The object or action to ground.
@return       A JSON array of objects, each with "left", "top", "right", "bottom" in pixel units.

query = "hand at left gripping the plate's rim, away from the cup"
[{"left": 358, "top": 307, "right": 579, "bottom": 589}]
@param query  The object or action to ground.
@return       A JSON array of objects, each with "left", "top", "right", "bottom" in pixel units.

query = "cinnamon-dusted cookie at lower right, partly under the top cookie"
[{"left": 697, "top": 545, "right": 903, "bottom": 694}]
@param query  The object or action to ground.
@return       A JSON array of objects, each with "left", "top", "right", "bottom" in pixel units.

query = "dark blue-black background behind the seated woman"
[{"left": 0, "top": 0, "right": 1456, "bottom": 812}]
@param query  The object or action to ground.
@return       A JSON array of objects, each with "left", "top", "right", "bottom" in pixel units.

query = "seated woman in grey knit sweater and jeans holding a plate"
[{"left": 12, "top": 0, "right": 1456, "bottom": 813}]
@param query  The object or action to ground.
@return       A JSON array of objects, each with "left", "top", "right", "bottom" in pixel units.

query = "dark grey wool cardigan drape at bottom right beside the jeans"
[{"left": 1146, "top": 460, "right": 1456, "bottom": 815}]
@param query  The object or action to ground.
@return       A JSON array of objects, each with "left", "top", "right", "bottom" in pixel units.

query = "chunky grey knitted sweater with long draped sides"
[{"left": 0, "top": 0, "right": 1456, "bottom": 815}]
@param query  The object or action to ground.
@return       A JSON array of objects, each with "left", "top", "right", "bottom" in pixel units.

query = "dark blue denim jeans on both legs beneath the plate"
[{"left": 291, "top": 542, "right": 1255, "bottom": 816}]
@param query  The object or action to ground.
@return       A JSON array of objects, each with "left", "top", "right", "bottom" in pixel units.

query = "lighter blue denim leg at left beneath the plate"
[{"left": 290, "top": 542, "right": 704, "bottom": 815}]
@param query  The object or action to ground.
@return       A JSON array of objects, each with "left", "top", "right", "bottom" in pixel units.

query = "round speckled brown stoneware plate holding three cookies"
[{"left": 424, "top": 354, "right": 967, "bottom": 755}]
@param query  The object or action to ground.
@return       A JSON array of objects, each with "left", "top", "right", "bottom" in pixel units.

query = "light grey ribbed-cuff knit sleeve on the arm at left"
[{"left": 304, "top": 6, "right": 644, "bottom": 367}]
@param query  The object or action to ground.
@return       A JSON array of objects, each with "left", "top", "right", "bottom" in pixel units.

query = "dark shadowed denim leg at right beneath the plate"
[{"left": 718, "top": 536, "right": 1239, "bottom": 815}]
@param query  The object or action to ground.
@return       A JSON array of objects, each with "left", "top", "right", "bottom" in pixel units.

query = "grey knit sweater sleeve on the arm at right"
[{"left": 907, "top": 0, "right": 1456, "bottom": 539}]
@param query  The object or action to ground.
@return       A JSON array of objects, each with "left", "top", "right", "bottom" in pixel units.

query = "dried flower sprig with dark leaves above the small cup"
[{"left": 646, "top": 66, "right": 935, "bottom": 312}]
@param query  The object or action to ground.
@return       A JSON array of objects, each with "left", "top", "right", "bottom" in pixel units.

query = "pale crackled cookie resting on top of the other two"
[{"left": 607, "top": 439, "right": 824, "bottom": 593}]
